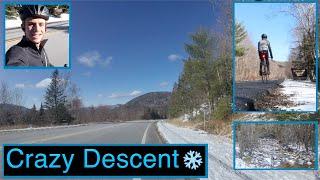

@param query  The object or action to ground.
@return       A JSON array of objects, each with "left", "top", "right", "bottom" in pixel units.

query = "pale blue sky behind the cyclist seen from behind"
[{"left": 235, "top": 3, "right": 316, "bottom": 61}]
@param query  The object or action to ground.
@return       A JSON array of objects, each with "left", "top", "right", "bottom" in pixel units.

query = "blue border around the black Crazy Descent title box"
[{"left": 0, "top": 144, "right": 209, "bottom": 179}]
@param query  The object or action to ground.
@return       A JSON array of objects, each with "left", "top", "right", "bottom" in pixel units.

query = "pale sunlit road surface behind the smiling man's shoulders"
[{"left": 5, "top": 21, "right": 70, "bottom": 67}]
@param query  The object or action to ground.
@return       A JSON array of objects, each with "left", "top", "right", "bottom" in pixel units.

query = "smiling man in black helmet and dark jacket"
[{"left": 6, "top": 5, "right": 52, "bottom": 66}]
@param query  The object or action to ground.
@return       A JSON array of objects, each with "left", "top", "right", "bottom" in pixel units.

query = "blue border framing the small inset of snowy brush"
[{"left": 232, "top": 121, "right": 319, "bottom": 171}]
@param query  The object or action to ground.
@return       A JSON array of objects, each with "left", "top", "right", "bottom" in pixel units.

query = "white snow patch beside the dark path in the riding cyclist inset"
[{"left": 279, "top": 79, "right": 316, "bottom": 111}]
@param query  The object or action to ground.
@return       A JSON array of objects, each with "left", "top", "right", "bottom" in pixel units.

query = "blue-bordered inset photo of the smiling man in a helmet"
[{"left": 3, "top": 1, "right": 71, "bottom": 69}]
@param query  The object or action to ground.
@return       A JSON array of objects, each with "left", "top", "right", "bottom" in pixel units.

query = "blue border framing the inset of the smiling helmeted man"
[{"left": 1, "top": 0, "right": 72, "bottom": 70}]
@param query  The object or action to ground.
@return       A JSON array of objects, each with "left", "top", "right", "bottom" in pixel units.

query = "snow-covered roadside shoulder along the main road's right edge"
[{"left": 158, "top": 121, "right": 315, "bottom": 180}]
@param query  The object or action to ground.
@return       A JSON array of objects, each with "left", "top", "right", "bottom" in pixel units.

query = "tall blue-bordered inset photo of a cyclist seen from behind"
[{"left": 232, "top": 0, "right": 319, "bottom": 112}]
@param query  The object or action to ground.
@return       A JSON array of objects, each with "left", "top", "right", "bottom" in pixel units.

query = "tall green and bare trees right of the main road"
[{"left": 169, "top": 1, "right": 232, "bottom": 126}]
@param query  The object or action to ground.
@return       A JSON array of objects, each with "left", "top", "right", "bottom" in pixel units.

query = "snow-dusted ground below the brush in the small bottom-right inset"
[{"left": 236, "top": 138, "right": 315, "bottom": 169}]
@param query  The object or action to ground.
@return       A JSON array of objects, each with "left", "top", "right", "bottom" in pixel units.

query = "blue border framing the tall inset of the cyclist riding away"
[{"left": 232, "top": 0, "right": 319, "bottom": 113}]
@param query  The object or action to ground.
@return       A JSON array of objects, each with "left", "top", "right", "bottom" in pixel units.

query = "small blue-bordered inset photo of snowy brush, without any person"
[{"left": 233, "top": 121, "right": 318, "bottom": 170}]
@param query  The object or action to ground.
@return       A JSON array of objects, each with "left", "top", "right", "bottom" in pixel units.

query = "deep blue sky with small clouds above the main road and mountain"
[{"left": 0, "top": 1, "right": 214, "bottom": 107}]
